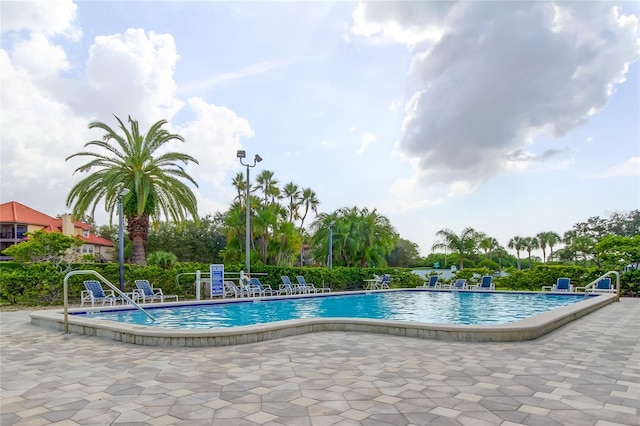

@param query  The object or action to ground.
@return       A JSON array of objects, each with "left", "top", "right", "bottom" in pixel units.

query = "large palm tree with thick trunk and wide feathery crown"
[{"left": 67, "top": 116, "right": 198, "bottom": 265}]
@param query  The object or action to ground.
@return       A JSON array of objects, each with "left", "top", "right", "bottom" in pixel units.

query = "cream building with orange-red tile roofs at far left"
[{"left": 0, "top": 201, "right": 114, "bottom": 262}]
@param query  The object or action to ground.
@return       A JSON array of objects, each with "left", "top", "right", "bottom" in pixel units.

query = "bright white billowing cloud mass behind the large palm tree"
[{"left": 0, "top": 10, "right": 253, "bottom": 222}]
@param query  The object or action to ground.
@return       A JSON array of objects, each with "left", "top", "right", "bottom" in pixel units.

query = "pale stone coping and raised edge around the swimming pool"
[{"left": 29, "top": 289, "right": 616, "bottom": 347}]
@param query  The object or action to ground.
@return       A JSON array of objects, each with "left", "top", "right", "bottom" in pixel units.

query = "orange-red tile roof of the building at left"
[{"left": 0, "top": 201, "right": 113, "bottom": 247}]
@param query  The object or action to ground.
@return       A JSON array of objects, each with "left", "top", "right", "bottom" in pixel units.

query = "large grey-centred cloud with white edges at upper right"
[{"left": 352, "top": 2, "right": 640, "bottom": 196}]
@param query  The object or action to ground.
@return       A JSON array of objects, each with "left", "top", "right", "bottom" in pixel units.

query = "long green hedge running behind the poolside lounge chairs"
[{"left": 0, "top": 262, "right": 640, "bottom": 305}]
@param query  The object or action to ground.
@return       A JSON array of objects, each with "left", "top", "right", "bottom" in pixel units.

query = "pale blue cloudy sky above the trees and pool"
[{"left": 0, "top": 0, "right": 640, "bottom": 255}]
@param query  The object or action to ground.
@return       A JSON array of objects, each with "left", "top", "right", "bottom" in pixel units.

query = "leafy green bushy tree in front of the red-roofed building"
[{"left": 2, "top": 230, "right": 83, "bottom": 269}]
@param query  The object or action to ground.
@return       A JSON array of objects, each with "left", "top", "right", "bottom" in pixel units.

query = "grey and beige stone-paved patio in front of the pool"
[{"left": 0, "top": 299, "right": 640, "bottom": 426}]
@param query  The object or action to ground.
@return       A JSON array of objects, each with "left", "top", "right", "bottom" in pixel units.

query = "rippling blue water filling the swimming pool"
[{"left": 75, "top": 291, "right": 584, "bottom": 329}]
